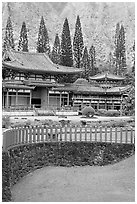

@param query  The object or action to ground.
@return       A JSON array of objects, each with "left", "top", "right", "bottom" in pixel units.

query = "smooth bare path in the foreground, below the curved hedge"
[{"left": 12, "top": 156, "right": 135, "bottom": 202}]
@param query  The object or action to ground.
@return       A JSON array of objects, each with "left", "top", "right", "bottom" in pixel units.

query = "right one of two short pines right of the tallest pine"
[{"left": 89, "top": 45, "right": 98, "bottom": 76}]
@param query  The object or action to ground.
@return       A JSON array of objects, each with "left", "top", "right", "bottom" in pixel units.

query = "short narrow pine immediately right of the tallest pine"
[{"left": 82, "top": 46, "right": 90, "bottom": 79}]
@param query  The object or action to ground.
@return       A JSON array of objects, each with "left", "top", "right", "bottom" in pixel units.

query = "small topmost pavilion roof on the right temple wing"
[{"left": 89, "top": 72, "right": 125, "bottom": 81}]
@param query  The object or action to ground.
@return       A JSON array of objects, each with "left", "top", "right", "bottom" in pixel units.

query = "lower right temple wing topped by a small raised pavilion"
[{"left": 53, "top": 72, "right": 131, "bottom": 110}]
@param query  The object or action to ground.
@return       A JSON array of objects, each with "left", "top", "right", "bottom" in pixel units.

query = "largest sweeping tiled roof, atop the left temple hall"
[{"left": 3, "top": 50, "right": 82, "bottom": 74}]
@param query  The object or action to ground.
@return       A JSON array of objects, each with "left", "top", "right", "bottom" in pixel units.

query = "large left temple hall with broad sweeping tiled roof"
[{"left": 2, "top": 50, "right": 81, "bottom": 109}]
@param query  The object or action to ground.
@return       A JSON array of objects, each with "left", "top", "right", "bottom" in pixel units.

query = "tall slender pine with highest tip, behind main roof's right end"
[{"left": 73, "top": 16, "right": 84, "bottom": 68}]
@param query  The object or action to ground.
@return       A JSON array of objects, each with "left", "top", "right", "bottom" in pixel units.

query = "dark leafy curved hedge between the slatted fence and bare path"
[{"left": 2, "top": 142, "right": 134, "bottom": 201}]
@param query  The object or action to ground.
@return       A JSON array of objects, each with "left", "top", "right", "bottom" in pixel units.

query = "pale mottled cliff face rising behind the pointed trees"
[{"left": 2, "top": 2, "right": 135, "bottom": 67}]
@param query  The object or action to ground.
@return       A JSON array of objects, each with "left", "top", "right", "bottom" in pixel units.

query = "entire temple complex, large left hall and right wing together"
[{"left": 2, "top": 50, "right": 130, "bottom": 110}]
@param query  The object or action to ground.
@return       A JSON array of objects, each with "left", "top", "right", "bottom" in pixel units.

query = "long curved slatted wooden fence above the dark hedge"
[{"left": 3, "top": 126, "right": 135, "bottom": 150}]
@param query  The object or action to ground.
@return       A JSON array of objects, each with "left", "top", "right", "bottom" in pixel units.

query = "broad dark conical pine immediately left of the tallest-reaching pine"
[{"left": 61, "top": 18, "right": 73, "bottom": 67}]
